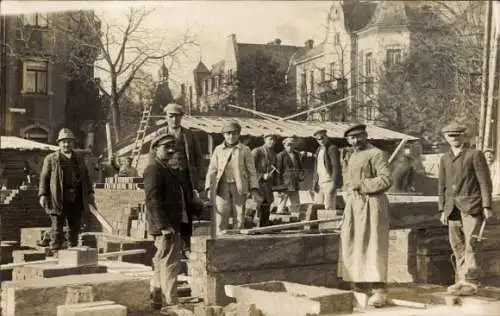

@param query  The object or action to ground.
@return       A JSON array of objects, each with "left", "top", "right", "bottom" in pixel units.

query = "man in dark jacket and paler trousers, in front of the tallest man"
[{"left": 144, "top": 134, "right": 198, "bottom": 309}]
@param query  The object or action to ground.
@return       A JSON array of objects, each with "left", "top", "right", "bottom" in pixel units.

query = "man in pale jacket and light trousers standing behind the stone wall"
[{"left": 205, "top": 121, "right": 260, "bottom": 234}]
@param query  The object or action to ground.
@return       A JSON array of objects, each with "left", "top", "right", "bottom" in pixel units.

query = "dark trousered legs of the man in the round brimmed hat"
[{"left": 50, "top": 203, "right": 83, "bottom": 250}]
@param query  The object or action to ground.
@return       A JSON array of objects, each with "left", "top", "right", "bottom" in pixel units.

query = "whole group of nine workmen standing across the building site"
[{"left": 36, "top": 104, "right": 498, "bottom": 313}]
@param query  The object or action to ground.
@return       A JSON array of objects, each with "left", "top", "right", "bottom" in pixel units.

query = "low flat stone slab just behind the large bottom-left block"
[{"left": 12, "top": 262, "right": 107, "bottom": 281}]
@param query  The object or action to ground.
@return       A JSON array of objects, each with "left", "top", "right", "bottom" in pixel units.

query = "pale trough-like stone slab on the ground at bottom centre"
[{"left": 225, "top": 281, "right": 354, "bottom": 316}]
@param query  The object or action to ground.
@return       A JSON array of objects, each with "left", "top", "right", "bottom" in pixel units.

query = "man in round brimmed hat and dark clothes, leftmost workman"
[{"left": 39, "top": 128, "right": 95, "bottom": 251}]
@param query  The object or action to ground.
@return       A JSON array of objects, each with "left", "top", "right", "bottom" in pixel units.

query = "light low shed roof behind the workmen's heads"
[{"left": 117, "top": 116, "right": 418, "bottom": 155}]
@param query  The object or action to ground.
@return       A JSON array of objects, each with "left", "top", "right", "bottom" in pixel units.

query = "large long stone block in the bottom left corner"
[{"left": 2, "top": 273, "right": 149, "bottom": 316}]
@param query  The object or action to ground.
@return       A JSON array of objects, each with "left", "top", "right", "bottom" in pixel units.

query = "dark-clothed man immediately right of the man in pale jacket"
[{"left": 252, "top": 134, "right": 277, "bottom": 227}]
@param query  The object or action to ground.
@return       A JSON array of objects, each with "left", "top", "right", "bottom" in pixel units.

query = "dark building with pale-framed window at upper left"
[{"left": 0, "top": 11, "right": 100, "bottom": 146}]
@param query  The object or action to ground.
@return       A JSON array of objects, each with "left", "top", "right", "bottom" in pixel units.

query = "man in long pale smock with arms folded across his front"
[{"left": 340, "top": 124, "right": 391, "bottom": 307}]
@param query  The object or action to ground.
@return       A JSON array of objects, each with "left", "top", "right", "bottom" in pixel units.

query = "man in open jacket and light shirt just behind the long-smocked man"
[{"left": 312, "top": 129, "right": 342, "bottom": 210}]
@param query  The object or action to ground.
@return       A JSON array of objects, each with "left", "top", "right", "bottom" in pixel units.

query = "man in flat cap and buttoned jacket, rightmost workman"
[{"left": 438, "top": 122, "right": 493, "bottom": 296}]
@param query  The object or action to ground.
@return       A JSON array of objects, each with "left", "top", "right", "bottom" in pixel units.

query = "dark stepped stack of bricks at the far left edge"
[{"left": 0, "top": 189, "right": 50, "bottom": 240}]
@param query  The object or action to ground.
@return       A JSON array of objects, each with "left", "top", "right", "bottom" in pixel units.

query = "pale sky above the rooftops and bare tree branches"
[{"left": 0, "top": 0, "right": 332, "bottom": 94}]
